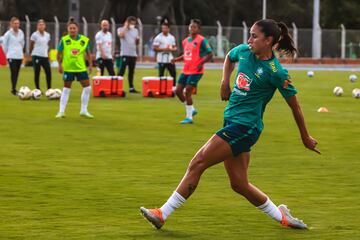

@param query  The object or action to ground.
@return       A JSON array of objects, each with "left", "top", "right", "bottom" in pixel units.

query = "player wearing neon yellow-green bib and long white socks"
[{"left": 56, "top": 18, "right": 94, "bottom": 118}]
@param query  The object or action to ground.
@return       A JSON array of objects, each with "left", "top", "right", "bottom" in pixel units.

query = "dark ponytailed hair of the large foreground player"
[{"left": 255, "top": 19, "right": 297, "bottom": 57}]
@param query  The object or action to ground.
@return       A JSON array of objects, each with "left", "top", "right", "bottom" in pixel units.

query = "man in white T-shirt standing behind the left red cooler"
[{"left": 95, "top": 20, "right": 115, "bottom": 76}]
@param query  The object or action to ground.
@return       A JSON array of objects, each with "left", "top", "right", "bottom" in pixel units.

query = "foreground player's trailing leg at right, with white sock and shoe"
[{"left": 224, "top": 152, "right": 307, "bottom": 229}]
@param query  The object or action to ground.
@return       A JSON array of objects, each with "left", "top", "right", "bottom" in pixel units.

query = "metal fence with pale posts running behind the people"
[{"left": 0, "top": 17, "right": 360, "bottom": 59}]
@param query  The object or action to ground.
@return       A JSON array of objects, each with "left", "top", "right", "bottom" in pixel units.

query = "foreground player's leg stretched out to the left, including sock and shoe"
[{"left": 140, "top": 135, "right": 232, "bottom": 229}]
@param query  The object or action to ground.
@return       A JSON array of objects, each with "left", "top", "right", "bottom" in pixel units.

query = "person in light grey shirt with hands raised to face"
[{"left": 117, "top": 16, "right": 139, "bottom": 93}]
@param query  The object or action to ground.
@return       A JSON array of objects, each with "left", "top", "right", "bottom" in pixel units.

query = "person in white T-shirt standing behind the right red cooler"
[{"left": 153, "top": 22, "right": 177, "bottom": 90}]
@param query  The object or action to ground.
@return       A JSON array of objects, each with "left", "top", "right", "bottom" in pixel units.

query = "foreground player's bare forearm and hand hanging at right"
[{"left": 286, "top": 96, "right": 321, "bottom": 154}]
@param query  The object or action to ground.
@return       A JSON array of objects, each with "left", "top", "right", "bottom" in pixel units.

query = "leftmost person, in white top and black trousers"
[{"left": 3, "top": 17, "right": 25, "bottom": 96}]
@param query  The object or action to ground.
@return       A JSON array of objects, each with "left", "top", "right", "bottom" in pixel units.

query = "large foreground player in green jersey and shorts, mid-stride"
[{"left": 140, "top": 19, "right": 320, "bottom": 229}]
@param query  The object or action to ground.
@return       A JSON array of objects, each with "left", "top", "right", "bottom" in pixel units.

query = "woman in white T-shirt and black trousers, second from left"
[{"left": 30, "top": 19, "right": 51, "bottom": 89}]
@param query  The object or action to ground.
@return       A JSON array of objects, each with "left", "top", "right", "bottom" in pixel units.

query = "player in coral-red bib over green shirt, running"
[{"left": 171, "top": 19, "right": 213, "bottom": 124}]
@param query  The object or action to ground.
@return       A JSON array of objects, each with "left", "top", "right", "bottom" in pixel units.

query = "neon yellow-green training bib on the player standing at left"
[{"left": 58, "top": 35, "right": 89, "bottom": 72}]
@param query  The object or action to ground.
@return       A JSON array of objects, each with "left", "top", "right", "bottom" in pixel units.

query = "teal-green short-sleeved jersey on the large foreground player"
[{"left": 224, "top": 44, "right": 297, "bottom": 132}]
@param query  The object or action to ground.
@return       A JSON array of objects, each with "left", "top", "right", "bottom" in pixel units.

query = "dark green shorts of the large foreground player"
[{"left": 216, "top": 120, "right": 260, "bottom": 157}]
